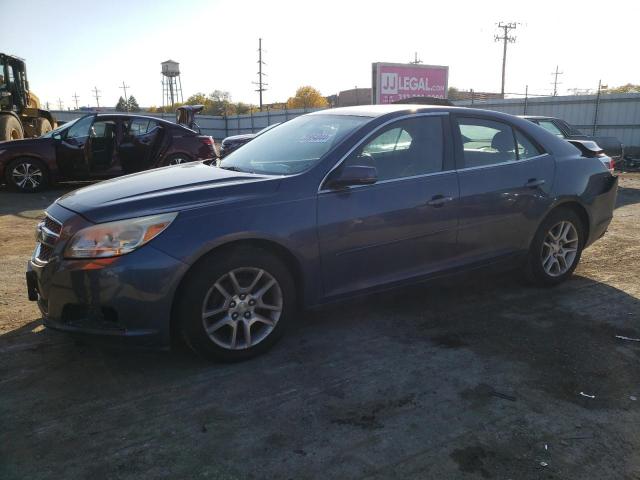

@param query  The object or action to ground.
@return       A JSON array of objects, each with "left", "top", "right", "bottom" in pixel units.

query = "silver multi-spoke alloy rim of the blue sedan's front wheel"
[{"left": 202, "top": 267, "right": 283, "bottom": 350}]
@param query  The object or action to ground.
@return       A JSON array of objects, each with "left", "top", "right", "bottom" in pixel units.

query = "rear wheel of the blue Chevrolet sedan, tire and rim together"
[{"left": 524, "top": 207, "right": 586, "bottom": 287}]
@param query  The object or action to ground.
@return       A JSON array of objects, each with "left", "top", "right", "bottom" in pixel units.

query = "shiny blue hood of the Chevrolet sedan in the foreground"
[{"left": 56, "top": 162, "right": 280, "bottom": 223}]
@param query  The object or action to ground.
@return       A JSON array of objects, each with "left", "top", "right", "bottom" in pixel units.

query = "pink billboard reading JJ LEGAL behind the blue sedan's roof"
[{"left": 372, "top": 63, "right": 449, "bottom": 104}]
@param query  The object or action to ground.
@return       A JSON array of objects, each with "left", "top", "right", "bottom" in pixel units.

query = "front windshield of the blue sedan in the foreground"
[{"left": 220, "top": 114, "right": 371, "bottom": 175}]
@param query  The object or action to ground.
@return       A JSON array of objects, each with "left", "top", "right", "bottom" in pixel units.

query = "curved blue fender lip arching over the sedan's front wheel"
[{"left": 169, "top": 238, "right": 304, "bottom": 342}]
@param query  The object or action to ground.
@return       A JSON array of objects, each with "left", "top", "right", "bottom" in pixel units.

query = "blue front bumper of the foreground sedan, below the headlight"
[{"left": 27, "top": 204, "right": 188, "bottom": 348}]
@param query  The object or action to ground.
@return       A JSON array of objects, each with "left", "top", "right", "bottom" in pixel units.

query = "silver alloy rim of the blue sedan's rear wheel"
[{"left": 540, "top": 220, "right": 579, "bottom": 277}]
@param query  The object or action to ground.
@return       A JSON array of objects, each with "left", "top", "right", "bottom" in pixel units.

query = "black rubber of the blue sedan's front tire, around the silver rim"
[{"left": 174, "top": 246, "right": 296, "bottom": 362}]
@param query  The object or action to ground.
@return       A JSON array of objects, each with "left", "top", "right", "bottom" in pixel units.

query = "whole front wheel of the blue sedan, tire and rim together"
[{"left": 176, "top": 247, "right": 296, "bottom": 362}]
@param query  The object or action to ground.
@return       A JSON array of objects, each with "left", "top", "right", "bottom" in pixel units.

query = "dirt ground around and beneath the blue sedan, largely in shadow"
[{"left": 0, "top": 174, "right": 640, "bottom": 480}]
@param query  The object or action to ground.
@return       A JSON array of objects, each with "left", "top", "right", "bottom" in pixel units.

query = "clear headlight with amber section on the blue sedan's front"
[{"left": 64, "top": 212, "right": 178, "bottom": 258}]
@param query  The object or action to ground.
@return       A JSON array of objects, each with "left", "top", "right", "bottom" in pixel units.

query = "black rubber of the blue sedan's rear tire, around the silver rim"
[{"left": 524, "top": 207, "right": 586, "bottom": 287}]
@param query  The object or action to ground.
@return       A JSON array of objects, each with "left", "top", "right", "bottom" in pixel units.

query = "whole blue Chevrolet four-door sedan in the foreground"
[{"left": 27, "top": 105, "right": 617, "bottom": 361}]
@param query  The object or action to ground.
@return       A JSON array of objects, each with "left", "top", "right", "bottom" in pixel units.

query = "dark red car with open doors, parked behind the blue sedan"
[{"left": 0, "top": 114, "right": 216, "bottom": 192}]
